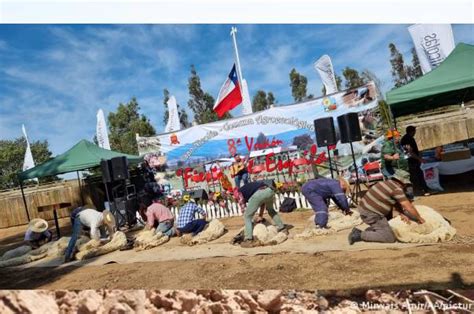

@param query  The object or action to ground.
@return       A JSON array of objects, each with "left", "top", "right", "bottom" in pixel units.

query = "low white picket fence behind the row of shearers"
[{"left": 170, "top": 192, "right": 311, "bottom": 219}]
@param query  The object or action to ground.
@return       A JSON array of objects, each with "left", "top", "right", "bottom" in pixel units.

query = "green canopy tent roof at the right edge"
[{"left": 387, "top": 43, "right": 474, "bottom": 117}]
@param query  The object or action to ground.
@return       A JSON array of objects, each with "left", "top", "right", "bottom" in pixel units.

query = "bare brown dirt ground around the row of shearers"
[{"left": 0, "top": 183, "right": 474, "bottom": 291}]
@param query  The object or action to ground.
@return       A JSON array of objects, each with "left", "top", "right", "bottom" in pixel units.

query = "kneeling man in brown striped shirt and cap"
[{"left": 349, "top": 169, "right": 424, "bottom": 245}]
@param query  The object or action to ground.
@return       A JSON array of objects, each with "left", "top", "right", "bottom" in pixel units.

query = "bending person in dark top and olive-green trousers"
[{"left": 234, "top": 181, "right": 286, "bottom": 248}]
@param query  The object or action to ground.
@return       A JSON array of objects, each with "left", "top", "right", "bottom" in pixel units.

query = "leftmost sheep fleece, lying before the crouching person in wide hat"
[{"left": 0, "top": 237, "right": 89, "bottom": 267}]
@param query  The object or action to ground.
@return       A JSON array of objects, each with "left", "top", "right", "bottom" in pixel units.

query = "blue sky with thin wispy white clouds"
[{"left": 0, "top": 24, "right": 474, "bottom": 155}]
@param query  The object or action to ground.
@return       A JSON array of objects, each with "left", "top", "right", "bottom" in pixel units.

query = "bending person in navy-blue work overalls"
[{"left": 301, "top": 178, "right": 352, "bottom": 228}]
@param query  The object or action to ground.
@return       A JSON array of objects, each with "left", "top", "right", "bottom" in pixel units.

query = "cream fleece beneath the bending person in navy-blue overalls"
[{"left": 295, "top": 210, "right": 362, "bottom": 239}]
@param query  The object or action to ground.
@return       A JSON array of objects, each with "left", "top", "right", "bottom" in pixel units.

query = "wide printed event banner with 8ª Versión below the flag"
[{"left": 137, "top": 82, "right": 378, "bottom": 166}]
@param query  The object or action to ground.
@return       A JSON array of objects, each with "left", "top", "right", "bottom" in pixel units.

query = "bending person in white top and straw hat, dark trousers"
[{"left": 65, "top": 208, "right": 115, "bottom": 263}]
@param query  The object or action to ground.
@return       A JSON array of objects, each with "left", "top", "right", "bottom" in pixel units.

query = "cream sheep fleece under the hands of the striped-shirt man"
[{"left": 388, "top": 205, "right": 456, "bottom": 243}]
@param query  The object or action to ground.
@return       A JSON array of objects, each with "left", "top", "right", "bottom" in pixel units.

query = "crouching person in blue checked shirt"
[{"left": 176, "top": 195, "right": 207, "bottom": 236}]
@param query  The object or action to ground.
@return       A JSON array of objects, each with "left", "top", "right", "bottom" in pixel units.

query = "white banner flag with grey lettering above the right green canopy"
[{"left": 408, "top": 24, "right": 454, "bottom": 74}]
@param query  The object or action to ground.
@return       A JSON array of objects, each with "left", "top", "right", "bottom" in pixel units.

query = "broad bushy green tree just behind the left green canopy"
[{"left": 108, "top": 97, "right": 156, "bottom": 155}]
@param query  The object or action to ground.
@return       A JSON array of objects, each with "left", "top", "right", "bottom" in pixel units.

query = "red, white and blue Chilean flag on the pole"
[{"left": 213, "top": 64, "right": 242, "bottom": 118}]
